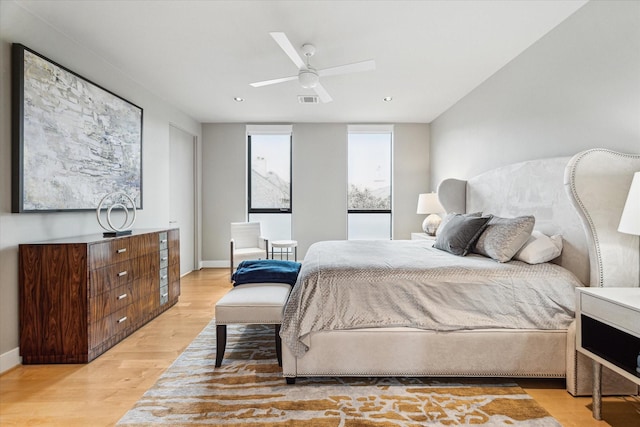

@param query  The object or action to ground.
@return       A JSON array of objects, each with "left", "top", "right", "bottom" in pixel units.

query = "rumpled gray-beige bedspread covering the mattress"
[{"left": 280, "top": 240, "right": 581, "bottom": 357}]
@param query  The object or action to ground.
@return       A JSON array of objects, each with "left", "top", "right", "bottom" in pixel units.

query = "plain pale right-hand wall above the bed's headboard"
[{"left": 431, "top": 1, "right": 640, "bottom": 184}]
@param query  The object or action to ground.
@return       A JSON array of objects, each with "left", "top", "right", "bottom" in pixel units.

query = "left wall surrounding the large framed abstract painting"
[{"left": 0, "top": 1, "right": 201, "bottom": 372}]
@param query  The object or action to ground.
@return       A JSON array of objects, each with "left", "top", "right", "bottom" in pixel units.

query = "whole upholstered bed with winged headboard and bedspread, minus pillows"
[{"left": 281, "top": 149, "right": 640, "bottom": 395}]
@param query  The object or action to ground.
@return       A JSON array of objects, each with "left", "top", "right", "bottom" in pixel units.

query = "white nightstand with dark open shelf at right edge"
[{"left": 576, "top": 287, "right": 640, "bottom": 420}]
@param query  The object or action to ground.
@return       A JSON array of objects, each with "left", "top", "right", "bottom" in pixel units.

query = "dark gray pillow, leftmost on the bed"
[{"left": 433, "top": 214, "right": 491, "bottom": 256}]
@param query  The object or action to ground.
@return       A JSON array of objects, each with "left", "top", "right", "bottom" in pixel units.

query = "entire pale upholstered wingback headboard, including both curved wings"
[{"left": 438, "top": 148, "right": 640, "bottom": 287}]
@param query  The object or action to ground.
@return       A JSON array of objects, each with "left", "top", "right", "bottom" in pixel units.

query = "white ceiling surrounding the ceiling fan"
[{"left": 17, "top": 0, "right": 586, "bottom": 123}]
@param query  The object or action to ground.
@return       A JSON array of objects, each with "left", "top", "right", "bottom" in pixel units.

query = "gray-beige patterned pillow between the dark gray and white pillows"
[{"left": 474, "top": 215, "right": 536, "bottom": 262}]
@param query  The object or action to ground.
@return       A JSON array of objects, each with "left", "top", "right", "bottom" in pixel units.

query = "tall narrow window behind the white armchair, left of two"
[{"left": 247, "top": 126, "right": 291, "bottom": 240}]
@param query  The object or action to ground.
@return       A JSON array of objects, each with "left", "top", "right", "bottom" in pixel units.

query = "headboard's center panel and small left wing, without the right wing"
[{"left": 438, "top": 157, "right": 589, "bottom": 285}]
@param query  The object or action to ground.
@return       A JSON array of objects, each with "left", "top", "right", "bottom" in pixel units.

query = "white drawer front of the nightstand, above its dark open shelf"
[{"left": 580, "top": 293, "right": 640, "bottom": 337}]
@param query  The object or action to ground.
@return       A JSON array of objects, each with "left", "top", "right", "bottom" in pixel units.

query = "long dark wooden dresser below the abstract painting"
[{"left": 19, "top": 229, "right": 180, "bottom": 364}]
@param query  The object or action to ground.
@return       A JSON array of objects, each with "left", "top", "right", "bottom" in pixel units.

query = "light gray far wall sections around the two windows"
[{"left": 202, "top": 123, "right": 433, "bottom": 267}]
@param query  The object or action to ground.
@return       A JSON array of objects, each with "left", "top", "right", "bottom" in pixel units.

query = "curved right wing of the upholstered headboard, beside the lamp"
[{"left": 565, "top": 148, "right": 640, "bottom": 287}]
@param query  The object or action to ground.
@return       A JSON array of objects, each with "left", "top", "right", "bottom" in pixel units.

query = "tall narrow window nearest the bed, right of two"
[{"left": 347, "top": 126, "right": 393, "bottom": 240}]
